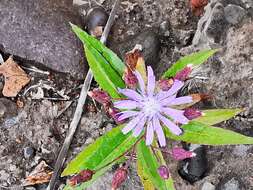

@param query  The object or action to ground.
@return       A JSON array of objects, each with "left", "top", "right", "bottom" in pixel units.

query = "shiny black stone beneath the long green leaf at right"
[{"left": 178, "top": 145, "right": 208, "bottom": 183}]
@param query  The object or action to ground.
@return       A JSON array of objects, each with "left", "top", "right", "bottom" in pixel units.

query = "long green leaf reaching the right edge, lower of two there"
[{"left": 164, "top": 121, "right": 253, "bottom": 145}]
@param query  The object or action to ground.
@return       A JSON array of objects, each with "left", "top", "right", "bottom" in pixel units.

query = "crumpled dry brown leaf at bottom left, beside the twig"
[{"left": 24, "top": 161, "right": 53, "bottom": 186}]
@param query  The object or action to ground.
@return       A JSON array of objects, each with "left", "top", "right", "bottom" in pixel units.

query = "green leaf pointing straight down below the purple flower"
[{"left": 137, "top": 140, "right": 173, "bottom": 190}]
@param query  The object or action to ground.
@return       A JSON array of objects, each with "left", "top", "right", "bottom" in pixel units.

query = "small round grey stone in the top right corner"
[{"left": 224, "top": 4, "right": 246, "bottom": 24}]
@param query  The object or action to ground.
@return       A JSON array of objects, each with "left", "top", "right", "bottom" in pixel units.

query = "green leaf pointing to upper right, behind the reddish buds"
[{"left": 163, "top": 49, "right": 218, "bottom": 78}]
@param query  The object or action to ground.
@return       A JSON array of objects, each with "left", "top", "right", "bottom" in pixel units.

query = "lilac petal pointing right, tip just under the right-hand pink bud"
[{"left": 161, "top": 107, "right": 189, "bottom": 124}]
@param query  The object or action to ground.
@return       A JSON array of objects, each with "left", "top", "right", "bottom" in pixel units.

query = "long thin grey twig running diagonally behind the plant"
[{"left": 47, "top": 0, "right": 119, "bottom": 190}]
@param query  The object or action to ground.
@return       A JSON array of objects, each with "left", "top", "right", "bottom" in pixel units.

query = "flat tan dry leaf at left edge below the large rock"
[{"left": 0, "top": 56, "right": 30, "bottom": 97}]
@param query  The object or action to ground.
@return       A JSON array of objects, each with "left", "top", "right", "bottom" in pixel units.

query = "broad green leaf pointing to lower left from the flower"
[{"left": 62, "top": 127, "right": 138, "bottom": 176}]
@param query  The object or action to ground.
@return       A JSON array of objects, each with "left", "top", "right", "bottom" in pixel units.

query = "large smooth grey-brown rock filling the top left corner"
[{"left": 0, "top": 0, "right": 85, "bottom": 78}]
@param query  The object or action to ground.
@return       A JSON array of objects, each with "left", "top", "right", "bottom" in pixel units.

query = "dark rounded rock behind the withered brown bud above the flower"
[{"left": 112, "top": 30, "right": 161, "bottom": 68}]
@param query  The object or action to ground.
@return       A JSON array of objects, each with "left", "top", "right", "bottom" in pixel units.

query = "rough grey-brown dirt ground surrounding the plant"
[{"left": 0, "top": 0, "right": 253, "bottom": 190}]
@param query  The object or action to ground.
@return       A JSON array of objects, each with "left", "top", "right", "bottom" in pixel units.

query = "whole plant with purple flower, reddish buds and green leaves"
[{"left": 62, "top": 25, "right": 253, "bottom": 190}]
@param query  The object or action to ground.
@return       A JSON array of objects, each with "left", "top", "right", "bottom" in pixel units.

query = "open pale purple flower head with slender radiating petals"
[{"left": 114, "top": 67, "right": 193, "bottom": 146}]
